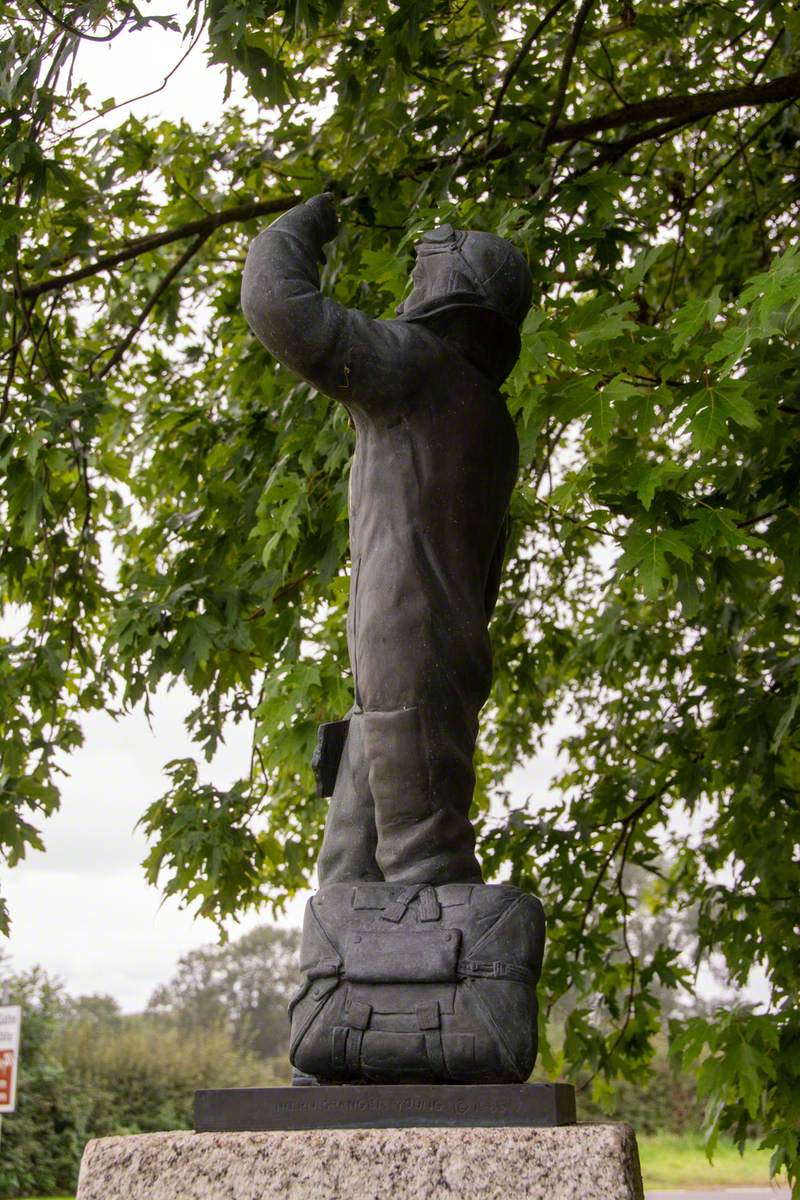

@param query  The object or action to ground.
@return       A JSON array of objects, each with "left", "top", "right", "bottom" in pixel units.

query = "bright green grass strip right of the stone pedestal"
[{"left": 637, "top": 1134, "right": 786, "bottom": 1188}]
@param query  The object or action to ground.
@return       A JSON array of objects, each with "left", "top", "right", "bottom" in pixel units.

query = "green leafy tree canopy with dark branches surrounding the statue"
[{"left": 0, "top": 0, "right": 800, "bottom": 1187}]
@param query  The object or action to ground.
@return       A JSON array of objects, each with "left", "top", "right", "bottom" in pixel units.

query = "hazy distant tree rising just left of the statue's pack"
[{"left": 148, "top": 925, "right": 300, "bottom": 1058}]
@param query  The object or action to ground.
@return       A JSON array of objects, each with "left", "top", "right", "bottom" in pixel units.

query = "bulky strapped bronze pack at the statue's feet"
[{"left": 289, "top": 883, "right": 545, "bottom": 1084}]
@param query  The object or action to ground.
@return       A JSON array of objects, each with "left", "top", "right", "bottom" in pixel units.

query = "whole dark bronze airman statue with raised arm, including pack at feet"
[{"left": 242, "top": 193, "right": 543, "bottom": 1081}]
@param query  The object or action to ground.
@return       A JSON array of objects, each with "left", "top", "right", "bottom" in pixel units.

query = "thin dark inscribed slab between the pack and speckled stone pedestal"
[{"left": 194, "top": 1084, "right": 575, "bottom": 1133}]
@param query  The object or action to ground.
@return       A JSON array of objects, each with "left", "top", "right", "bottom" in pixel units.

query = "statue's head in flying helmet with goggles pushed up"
[{"left": 397, "top": 224, "right": 533, "bottom": 370}]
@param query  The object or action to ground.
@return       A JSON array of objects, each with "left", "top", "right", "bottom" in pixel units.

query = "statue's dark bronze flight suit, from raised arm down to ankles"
[{"left": 237, "top": 197, "right": 529, "bottom": 884}]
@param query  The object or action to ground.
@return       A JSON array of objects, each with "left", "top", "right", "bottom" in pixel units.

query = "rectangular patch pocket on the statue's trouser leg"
[{"left": 362, "top": 706, "right": 433, "bottom": 829}]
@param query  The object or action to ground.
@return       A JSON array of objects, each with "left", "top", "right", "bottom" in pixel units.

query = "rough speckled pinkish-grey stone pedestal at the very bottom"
[{"left": 78, "top": 1124, "right": 643, "bottom": 1200}]
